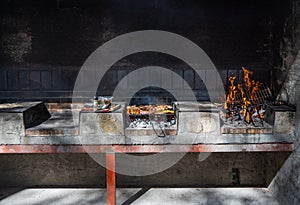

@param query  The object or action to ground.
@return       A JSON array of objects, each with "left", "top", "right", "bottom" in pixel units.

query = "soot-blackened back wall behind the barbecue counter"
[{"left": 0, "top": 0, "right": 292, "bottom": 101}]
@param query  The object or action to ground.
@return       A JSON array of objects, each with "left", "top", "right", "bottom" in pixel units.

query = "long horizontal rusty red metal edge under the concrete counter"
[{"left": 0, "top": 143, "right": 293, "bottom": 154}]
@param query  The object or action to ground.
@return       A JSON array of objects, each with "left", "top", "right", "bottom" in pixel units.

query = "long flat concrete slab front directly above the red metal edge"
[{"left": 15, "top": 134, "right": 293, "bottom": 145}]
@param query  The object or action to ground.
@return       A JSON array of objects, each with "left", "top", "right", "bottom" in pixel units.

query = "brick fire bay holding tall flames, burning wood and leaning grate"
[{"left": 221, "top": 67, "right": 295, "bottom": 134}]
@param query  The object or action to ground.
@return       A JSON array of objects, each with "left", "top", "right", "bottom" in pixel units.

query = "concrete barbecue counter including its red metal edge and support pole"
[{"left": 0, "top": 103, "right": 293, "bottom": 204}]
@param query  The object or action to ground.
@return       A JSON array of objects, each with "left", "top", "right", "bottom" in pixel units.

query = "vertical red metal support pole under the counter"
[{"left": 106, "top": 153, "right": 116, "bottom": 205}]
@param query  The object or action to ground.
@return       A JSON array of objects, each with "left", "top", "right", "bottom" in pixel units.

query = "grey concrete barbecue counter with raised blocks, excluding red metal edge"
[{"left": 0, "top": 102, "right": 293, "bottom": 145}]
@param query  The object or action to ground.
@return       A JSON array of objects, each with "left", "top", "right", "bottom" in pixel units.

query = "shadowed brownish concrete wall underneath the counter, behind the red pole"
[{"left": 0, "top": 153, "right": 289, "bottom": 187}]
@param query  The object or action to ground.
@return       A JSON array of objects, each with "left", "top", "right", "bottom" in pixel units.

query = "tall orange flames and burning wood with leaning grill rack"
[{"left": 224, "top": 67, "right": 273, "bottom": 127}]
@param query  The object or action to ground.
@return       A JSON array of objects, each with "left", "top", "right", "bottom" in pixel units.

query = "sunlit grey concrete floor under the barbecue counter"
[{"left": 0, "top": 188, "right": 280, "bottom": 205}]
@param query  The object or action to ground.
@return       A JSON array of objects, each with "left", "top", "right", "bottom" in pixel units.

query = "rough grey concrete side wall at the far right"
[{"left": 269, "top": 0, "right": 300, "bottom": 205}]
